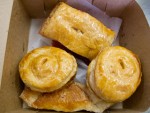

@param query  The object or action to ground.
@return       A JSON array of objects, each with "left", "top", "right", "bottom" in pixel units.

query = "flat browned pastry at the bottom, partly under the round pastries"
[{"left": 20, "top": 83, "right": 105, "bottom": 113}]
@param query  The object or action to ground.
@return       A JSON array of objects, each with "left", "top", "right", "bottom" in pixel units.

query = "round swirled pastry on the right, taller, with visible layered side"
[{"left": 87, "top": 46, "right": 142, "bottom": 103}]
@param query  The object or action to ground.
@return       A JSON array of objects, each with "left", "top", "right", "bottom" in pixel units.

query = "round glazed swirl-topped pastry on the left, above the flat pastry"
[{"left": 19, "top": 47, "right": 77, "bottom": 92}]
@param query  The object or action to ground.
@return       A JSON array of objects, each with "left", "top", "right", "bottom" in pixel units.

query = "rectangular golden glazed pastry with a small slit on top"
[{"left": 40, "top": 2, "right": 115, "bottom": 59}]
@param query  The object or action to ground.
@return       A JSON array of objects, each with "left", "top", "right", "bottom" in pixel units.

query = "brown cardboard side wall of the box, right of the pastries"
[{"left": 120, "top": 2, "right": 150, "bottom": 111}]
